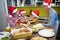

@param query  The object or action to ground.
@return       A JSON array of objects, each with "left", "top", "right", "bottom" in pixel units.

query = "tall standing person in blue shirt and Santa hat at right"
[{"left": 43, "top": 0, "right": 59, "bottom": 33}]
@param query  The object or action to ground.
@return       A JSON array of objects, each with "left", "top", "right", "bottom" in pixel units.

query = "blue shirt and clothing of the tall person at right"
[{"left": 43, "top": 8, "right": 59, "bottom": 32}]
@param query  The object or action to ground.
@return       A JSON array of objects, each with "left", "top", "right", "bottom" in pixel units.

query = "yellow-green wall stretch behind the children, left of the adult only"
[{"left": 17, "top": 6, "right": 47, "bottom": 17}]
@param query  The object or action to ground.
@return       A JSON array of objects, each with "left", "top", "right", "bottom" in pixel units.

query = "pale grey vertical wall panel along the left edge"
[{"left": 0, "top": 0, "right": 8, "bottom": 31}]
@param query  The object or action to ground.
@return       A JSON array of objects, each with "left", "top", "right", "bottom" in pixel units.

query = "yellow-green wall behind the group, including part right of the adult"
[{"left": 17, "top": 6, "right": 60, "bottom": 17}]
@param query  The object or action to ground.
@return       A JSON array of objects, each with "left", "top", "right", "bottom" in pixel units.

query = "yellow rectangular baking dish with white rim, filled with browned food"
[{"left": 11, "top": 28, "right": 32, "bottom": 39}]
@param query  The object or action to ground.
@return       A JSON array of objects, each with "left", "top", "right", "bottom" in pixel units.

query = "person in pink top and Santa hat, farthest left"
[{"left": 7, "top": 6, "right": 18, "bottom": 27}]
